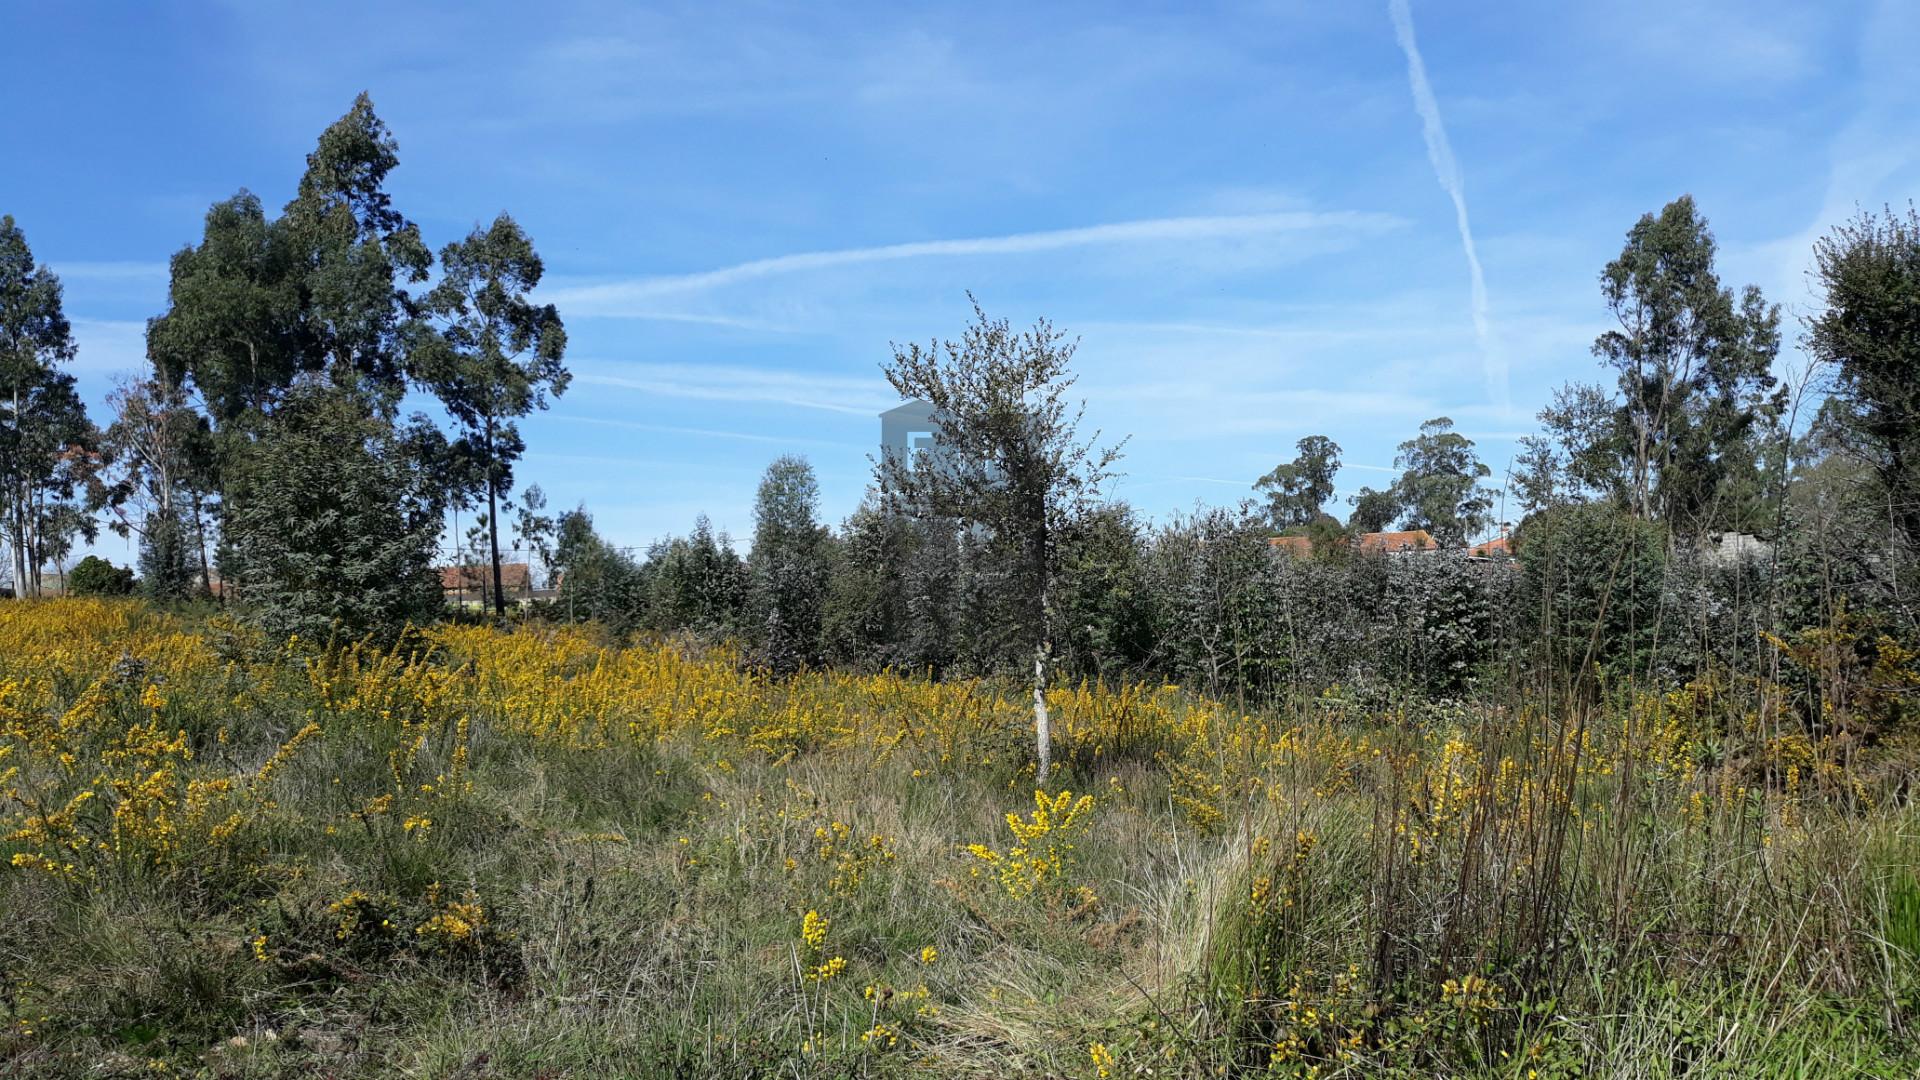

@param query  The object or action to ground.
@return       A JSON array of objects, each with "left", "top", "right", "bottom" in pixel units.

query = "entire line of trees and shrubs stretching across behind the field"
[{"left": 0, "top": 113, "right": 1920, "bottom": 718}]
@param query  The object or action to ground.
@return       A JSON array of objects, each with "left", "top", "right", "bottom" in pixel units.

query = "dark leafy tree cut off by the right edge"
[{"left": 1807, "top": 206, "right": 1920, "bottom": 544}]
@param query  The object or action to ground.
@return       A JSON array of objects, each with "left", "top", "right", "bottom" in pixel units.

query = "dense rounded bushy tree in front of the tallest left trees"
[{"left": 221, "top": 382, "right": 442, "bottom": 640}]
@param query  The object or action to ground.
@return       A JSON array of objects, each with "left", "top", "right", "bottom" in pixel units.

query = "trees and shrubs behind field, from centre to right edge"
[{"left": 555, "top": 198, "right": 1920, "bottom": 722}]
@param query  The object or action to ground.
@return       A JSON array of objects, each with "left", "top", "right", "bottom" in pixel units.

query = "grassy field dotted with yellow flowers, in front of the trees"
[{"left": 0, "top": 601, "right": 1920, "bottom": 1080}]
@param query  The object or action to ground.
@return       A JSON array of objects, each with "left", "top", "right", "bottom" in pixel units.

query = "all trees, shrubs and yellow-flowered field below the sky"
[{"left": 0, "top": 58, "right": 1920, "bottom": 1080}]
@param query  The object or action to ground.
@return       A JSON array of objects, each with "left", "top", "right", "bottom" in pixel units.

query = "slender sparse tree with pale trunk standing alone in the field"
[{"left": 876, "top": 298, "right": 1119, "bottom": 784}]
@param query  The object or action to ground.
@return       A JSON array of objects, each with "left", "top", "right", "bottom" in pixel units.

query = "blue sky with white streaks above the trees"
[{"left": 0, "top": 0, "right": 1920, "bottom": 555}]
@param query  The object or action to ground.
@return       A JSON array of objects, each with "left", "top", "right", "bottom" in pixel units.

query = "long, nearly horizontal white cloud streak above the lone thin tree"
[{"left": 543, "top": 211, "right": 1402, "bottom": 317}]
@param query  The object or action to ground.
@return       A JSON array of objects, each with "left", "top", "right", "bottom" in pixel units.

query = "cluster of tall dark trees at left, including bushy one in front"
[{"left": 0, "top": 94, "right": 568, "bottom": 638}]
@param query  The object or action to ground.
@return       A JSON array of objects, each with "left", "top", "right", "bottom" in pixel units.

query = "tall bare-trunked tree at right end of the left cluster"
[{"left": 413, "top": 213, "right": 568, "bottom": 615}]
